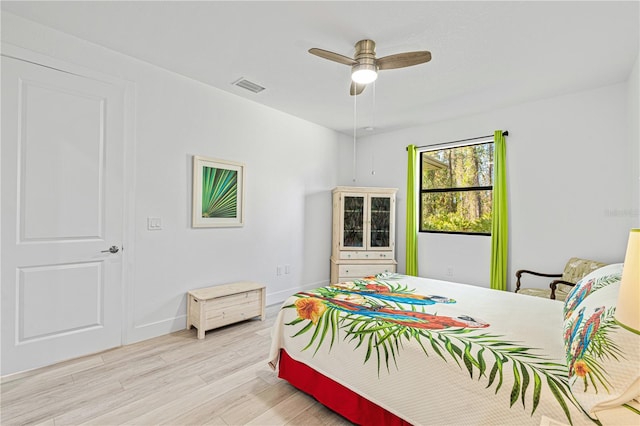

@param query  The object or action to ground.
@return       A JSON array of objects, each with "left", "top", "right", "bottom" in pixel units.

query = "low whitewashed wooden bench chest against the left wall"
[{"left": 187, "top": 281, "right": 266, "bottom": 339}]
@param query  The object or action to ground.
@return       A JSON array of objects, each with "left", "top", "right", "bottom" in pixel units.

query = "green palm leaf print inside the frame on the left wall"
[{"left": 202, "top": 167, "right": 238, "bottom": 218}]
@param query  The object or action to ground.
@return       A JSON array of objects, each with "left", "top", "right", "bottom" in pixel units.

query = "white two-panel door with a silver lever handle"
[{"left": 0, "top": 56, "right": 124, "bottom": 375}]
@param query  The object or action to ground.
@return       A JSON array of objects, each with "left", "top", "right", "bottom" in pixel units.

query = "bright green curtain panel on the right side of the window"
[{"left": 490, "top": 130, "right": 509, "bottom": 290}]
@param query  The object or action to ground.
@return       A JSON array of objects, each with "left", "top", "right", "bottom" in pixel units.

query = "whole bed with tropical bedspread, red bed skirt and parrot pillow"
[{"left": 269, "top": 264, "right": 640, "bottom": 425}]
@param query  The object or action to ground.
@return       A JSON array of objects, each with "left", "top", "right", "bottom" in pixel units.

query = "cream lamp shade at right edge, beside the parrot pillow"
[{"left": 615, "top": 229, "right": 640, "bottom": 333}]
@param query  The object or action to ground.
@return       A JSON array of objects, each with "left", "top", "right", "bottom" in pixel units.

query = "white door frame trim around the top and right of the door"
[{"left": 0, "top": 41, "right": 136, "bottom": 355}]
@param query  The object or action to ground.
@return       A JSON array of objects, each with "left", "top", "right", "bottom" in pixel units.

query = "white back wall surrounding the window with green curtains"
[{"left": 340, "top": 80, "right": 639, "bottom": 288}]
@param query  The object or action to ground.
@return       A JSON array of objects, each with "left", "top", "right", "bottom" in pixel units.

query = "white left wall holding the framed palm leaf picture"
[{"left": 2, "top": 13, "right": 340, "bottom": 342}]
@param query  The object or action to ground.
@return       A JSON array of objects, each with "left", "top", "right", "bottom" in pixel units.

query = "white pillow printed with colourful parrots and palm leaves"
[{"left": 563, "top": 263, "right": 640, "bottom": 415}]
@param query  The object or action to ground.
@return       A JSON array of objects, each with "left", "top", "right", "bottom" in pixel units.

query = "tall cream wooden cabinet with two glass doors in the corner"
[{"left": 331, "top": 186, "right": 397, "bottom": 284}]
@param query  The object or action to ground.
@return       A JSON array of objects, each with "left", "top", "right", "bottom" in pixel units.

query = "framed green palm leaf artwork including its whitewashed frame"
[{"left": 192, "top": 155, "right": 244, "bottom": 228}]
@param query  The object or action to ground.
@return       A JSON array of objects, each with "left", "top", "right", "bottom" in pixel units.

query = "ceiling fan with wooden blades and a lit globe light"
[{"left": 309, "top": 40, "right": 431, "bottom": 96}]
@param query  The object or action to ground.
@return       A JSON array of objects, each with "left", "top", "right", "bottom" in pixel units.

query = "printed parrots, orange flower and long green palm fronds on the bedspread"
[{"left": 282, "top": 280, "right": 592, "bottom": 423}]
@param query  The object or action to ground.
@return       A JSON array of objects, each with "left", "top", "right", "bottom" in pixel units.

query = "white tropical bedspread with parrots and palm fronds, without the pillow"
[{"left": 270, "top": 275, "right": 604, "bottom": 425}]
